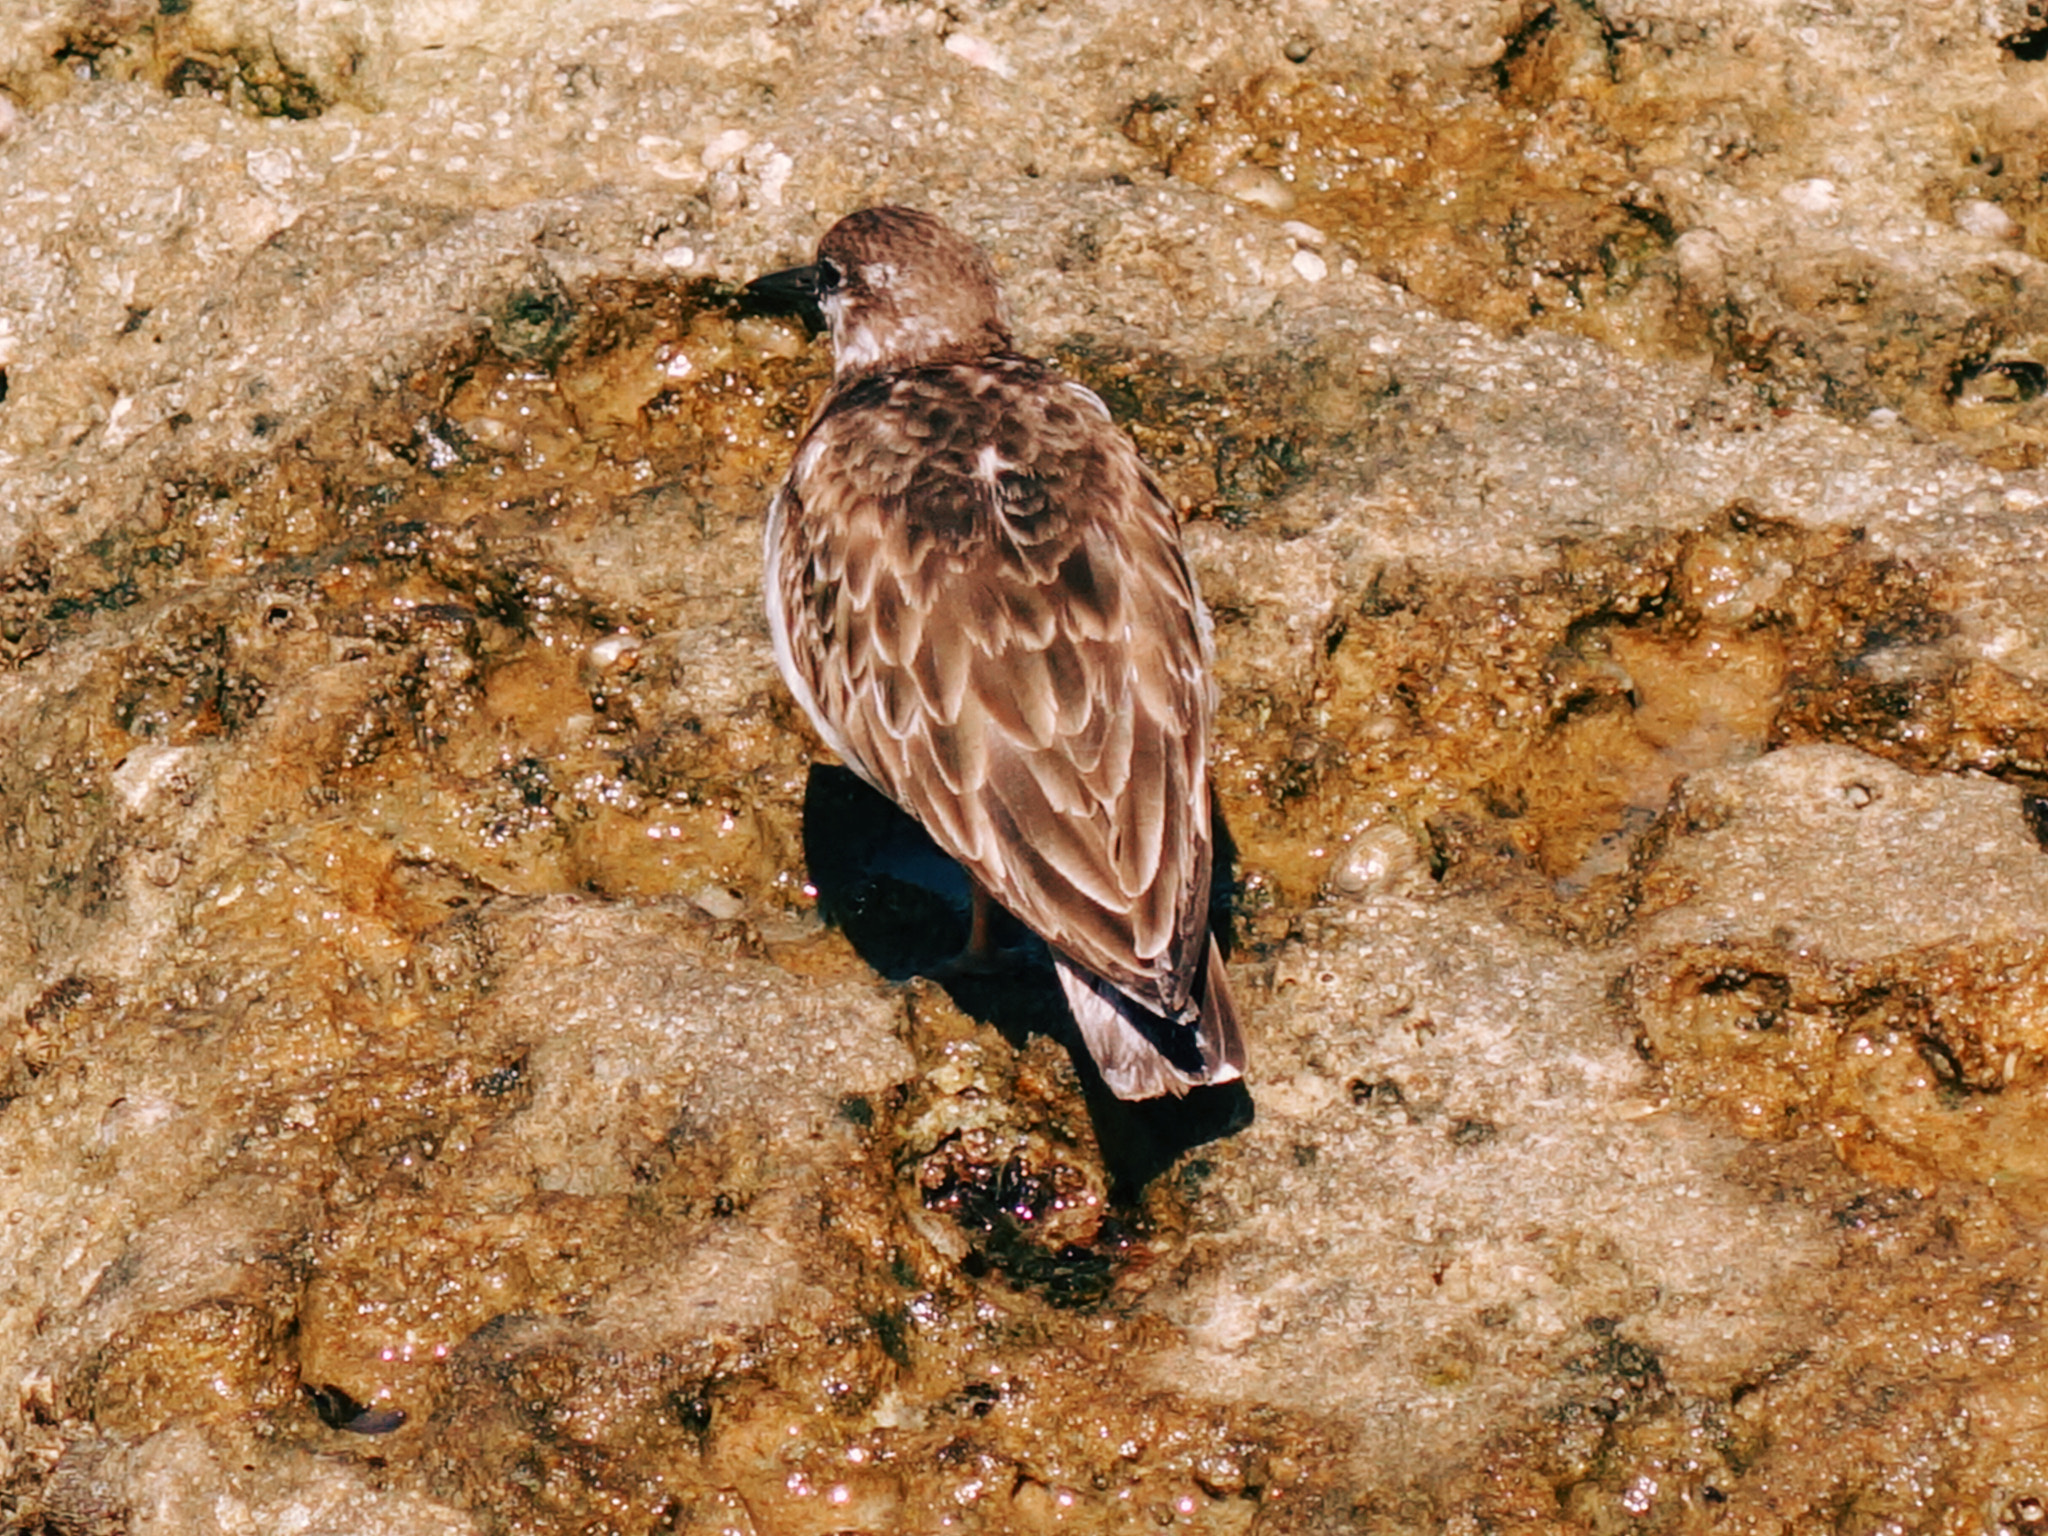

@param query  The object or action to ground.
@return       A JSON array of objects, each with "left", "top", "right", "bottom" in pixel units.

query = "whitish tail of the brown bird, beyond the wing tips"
[{"left": 1053, "top": 936, "right": 1245, "bottom": 1098}]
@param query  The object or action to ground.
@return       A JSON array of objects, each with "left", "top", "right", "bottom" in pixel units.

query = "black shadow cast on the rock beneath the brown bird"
[{"left": 803, "top": 764, "right": 1253, "bottom": 1202}]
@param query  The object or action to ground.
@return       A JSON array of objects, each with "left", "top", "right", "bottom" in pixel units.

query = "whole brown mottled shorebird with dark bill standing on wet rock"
[{"left": 745, "top": 207, "right": 1245, "bottom": 1100}]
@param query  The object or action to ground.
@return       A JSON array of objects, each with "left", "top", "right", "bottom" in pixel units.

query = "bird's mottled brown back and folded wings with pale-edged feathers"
[{"left": 770, "top": 358, "right": 1212, "bottom": 1016}]
